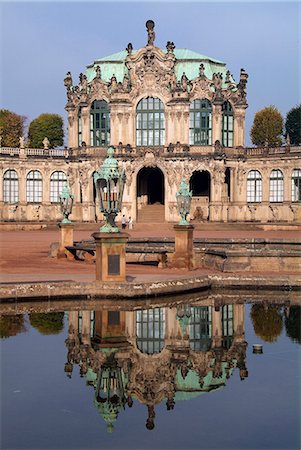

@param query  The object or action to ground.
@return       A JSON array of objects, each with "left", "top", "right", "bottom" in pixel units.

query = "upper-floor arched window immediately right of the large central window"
[{"left": 189, "top": 98, "right": 212, "bottom": 145}]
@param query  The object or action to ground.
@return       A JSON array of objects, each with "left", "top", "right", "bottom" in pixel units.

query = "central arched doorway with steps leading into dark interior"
[{"left": 137, "top": 167, "right": 164, "bottom": 223}]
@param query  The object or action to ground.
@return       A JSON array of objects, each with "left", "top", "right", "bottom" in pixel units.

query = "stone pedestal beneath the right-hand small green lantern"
[{"left": 168, "top": 225, "right": 195, "bottom": 270}]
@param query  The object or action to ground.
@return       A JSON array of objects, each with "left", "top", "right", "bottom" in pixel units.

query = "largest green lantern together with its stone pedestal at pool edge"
[{"left": 92, "top": 147, "right": 128, "bottom": 282}]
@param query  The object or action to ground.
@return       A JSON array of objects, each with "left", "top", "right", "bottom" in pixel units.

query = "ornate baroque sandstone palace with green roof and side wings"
[{"left": 0, "top": 20, "right": 301, "bottom": 223}]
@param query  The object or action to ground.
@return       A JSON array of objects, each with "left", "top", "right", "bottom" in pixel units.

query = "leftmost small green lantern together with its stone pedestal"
[{"left": 57, "top": 183, "right": 74, "bottom": 259}]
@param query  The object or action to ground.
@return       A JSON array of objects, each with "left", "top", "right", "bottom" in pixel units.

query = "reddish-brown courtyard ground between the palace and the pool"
[{"left": 0, "top": 224, "right": 300, "bottom": 283}]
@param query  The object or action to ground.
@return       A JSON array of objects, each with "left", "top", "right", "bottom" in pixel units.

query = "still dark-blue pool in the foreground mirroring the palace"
[{"left": 0, "top": 301, "right": 301, "bottom": 450}]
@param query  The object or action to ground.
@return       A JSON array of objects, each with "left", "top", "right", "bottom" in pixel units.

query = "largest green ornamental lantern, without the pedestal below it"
[{"left": 94, "top": 147, "right": 126, "bottom": 233}]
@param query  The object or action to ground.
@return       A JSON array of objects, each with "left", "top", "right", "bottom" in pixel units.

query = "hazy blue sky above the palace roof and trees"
[{"left": 0, "top": 0, "right": 301, "bottom": 145}]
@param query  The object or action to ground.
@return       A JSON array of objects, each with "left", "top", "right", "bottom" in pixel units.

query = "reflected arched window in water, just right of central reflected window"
[{"left": 189, "top": 306, "right": 212, "bottom": 352}]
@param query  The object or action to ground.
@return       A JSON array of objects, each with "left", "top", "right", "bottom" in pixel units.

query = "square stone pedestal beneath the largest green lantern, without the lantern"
[{"left": 92, "top": 232, "right": 129, "bottom": 282}]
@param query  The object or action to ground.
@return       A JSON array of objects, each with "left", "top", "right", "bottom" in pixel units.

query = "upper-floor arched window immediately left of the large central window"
[{"left": 90, "top": 100, "right": 110, "bottom": 147}]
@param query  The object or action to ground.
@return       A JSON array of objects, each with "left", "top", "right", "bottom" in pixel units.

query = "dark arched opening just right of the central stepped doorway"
[{"left": 189, "top": 170, "right": 211, "bottom": 222}]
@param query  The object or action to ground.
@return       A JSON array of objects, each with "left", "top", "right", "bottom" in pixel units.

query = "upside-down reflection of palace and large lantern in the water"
[{"left": 65, "top": 304, "right": 248, "bottom": 431}]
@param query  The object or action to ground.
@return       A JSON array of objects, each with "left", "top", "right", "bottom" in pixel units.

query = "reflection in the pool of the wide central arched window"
[{"left": 136, "top": 308, "right": 165, "bottom": 355}]
